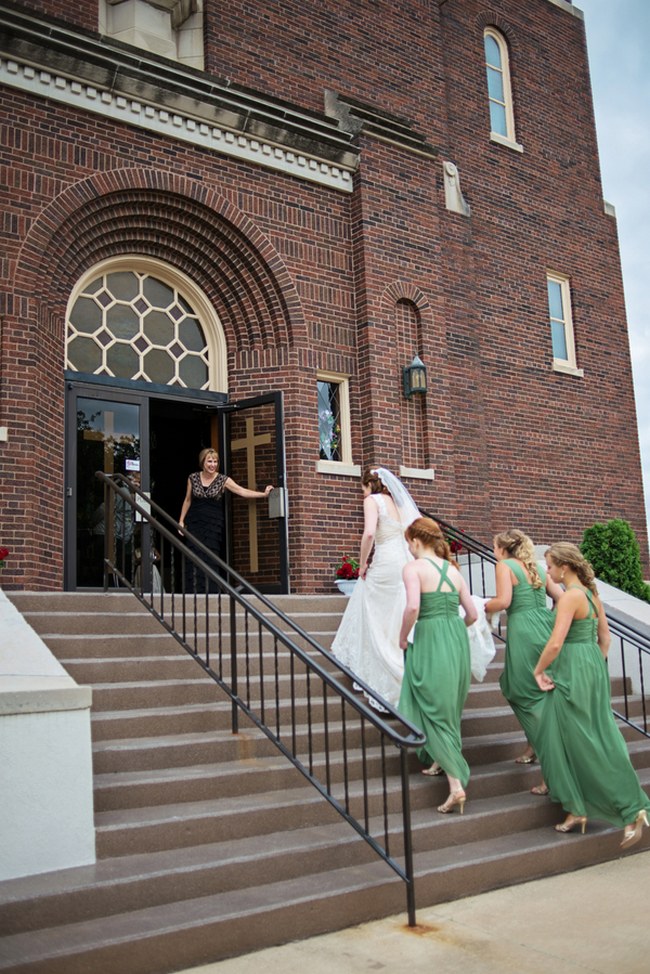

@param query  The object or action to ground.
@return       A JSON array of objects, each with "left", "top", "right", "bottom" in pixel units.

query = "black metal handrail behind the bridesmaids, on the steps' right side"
[{"left": 427, "top": 514, "right": 650, "bottom": 737}]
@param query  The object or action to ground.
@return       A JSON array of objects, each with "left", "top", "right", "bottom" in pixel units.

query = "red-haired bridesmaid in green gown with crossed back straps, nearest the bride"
[{"left": 398, "top": 517, "right": 477, "bottom": 815}]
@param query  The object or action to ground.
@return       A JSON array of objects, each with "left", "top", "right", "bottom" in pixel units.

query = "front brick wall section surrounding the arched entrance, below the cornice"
[{"left": 0, "top": 90, "right": 358, "bottom": 588}]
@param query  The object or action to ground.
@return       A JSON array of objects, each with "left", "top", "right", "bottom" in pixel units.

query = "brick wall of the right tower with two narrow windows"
[{"left": 441, "top": 2, "right": 645, "bottom": 546}]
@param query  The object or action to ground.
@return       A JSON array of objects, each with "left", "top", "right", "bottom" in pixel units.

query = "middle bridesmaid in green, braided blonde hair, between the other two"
[{"left": 485, "top": 528, "right": 562, "bottom": 795}]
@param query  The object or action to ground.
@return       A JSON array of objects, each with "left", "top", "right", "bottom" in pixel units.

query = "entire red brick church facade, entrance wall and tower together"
[{"left": 0, "top": 0, "right": 647, "bottom": 591}]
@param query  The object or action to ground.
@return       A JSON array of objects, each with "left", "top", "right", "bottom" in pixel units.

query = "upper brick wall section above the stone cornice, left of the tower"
[{"left": 205, "top": 0, "right": 444, "bottom": 138}]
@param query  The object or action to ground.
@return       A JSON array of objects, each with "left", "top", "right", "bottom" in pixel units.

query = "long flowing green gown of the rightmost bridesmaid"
[{"left": 537, "top": 585, "right": 650, "bottom": 826}]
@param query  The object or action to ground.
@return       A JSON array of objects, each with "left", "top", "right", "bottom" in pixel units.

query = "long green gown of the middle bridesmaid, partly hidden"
[{"left": 499, "top": 558, "right": 555, "bottom": 753}]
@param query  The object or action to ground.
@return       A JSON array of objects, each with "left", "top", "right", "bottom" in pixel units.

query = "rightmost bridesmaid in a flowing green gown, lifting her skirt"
[{"left": 534, "top": 542, "right": 650, "bottom": 849}]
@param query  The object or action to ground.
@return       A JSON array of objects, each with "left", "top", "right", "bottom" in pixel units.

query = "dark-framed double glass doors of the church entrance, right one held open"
[{"left": 65, "top": 381, "right": 289, "bottom": 593}]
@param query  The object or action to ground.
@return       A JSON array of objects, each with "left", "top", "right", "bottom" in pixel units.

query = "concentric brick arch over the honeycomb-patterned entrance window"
[{"left": 15, "top": 169, "right": 307, "bottom": 351}]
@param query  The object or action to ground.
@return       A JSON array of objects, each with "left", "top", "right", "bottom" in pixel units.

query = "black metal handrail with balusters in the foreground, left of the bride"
[{"left": 96, "top": 471, "right": 425, "bottom": 926}]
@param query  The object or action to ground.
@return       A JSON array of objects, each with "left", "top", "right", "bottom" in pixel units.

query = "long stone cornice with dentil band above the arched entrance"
[{"left": 0, "top": 4, "right": 359, "bottom": 193}]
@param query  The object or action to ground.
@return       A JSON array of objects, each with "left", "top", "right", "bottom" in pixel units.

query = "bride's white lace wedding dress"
[{"left": 332, "top": 494, "right": 411, "bottom": 709}]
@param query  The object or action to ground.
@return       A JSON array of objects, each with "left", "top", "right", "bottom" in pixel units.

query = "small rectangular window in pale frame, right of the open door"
[{"left": 317, "top": 372, "right": 360, "bottom": 474}]
